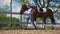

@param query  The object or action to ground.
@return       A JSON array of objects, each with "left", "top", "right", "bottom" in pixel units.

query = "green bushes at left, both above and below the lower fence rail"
[{"left": 0, "top": 14, "right": 20, "bottom": 29}]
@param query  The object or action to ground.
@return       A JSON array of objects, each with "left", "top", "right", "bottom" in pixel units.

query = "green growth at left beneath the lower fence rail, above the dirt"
[{"left": 0, "top": 24, "right": 21, "bottom": 30}]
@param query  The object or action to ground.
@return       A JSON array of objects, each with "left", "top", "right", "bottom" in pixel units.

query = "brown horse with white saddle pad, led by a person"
[{"left": 20, "top": 4, "right": 55, "bottom": 29}]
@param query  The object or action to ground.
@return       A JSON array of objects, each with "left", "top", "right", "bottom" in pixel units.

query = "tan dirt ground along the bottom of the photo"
[{"left": 0, "top": 30, "right": 60, "bottom": 34}]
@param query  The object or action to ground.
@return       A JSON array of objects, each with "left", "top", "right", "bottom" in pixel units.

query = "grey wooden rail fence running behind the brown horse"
[{"left": 0, "top": 12, "right": 60, "bottom": 28}]
